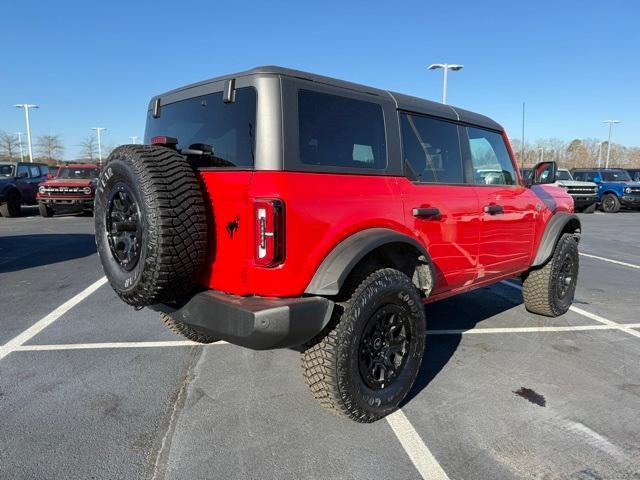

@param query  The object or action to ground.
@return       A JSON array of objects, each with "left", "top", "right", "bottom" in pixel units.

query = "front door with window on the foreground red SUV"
[{"left": 463, "top": 126, "right": 542, "bottom": 281}]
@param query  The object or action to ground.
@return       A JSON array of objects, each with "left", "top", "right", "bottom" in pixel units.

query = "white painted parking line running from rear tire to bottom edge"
[{"left": 386, "top": 410, "right": 449, "bottom": 480}]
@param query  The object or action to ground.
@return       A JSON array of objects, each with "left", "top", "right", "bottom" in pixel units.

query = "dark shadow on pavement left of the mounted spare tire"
[{"left": 0, "top": 233, "right": 96, "bottom": 273}]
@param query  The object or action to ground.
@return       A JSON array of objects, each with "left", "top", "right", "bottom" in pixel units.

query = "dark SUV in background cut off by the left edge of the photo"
[{"left": 0, "top": 162, "right": 49, "bottom": 217}]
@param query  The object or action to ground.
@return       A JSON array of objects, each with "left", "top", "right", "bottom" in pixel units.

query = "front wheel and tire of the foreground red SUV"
[{"left": 522, "top": 233, "right": 579, "bottom": 317}]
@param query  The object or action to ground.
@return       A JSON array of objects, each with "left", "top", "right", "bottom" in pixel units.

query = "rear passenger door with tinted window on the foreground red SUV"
[{"left": 399, "top": 113, "right": 479, "bottom": 294}]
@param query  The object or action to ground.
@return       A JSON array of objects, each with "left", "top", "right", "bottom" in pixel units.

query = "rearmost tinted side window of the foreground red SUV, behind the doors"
[{"left": 298, "top": 90, "right": 387, "bottom": 169}]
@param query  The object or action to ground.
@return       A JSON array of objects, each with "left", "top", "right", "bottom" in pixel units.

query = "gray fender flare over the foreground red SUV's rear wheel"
[{"left": 305, "top": 228, "right": 435, "bottom": 295}]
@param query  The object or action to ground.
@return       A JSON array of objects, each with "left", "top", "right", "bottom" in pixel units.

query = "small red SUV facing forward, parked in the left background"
[{"left": 37, "top": 163, "right": 100, "bottom": 217}]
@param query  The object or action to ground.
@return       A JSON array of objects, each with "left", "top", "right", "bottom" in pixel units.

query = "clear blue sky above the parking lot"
[{"left": 0, "top": 0, "right": 640, "bottom": 159}]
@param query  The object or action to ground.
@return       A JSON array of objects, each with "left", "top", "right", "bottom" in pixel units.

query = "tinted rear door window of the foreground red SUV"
[{"left": 400, "top": 114, "right": 464, "bottom": 183}]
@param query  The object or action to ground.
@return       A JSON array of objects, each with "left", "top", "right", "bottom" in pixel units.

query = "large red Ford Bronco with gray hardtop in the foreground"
[{"left": 95, "top": 67, "right": 580, "bottom": 422}]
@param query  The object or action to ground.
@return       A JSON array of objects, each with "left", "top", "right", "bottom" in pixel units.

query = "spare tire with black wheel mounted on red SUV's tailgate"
[{"left": 94, "top": 145, "right": 207, "bottom": 307}]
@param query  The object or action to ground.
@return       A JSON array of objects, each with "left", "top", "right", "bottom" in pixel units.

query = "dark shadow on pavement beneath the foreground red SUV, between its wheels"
[{"left": 400, "top": 286, "right": 522, "bottom": 407}]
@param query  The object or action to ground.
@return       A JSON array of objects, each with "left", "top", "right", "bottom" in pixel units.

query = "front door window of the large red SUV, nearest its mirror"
[{"left": 467, "top": 127, "right": 518, "bottom": 185}]
